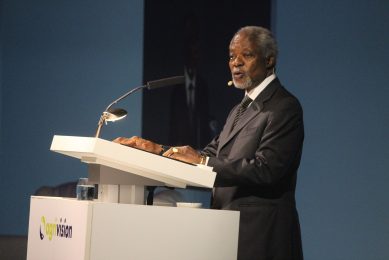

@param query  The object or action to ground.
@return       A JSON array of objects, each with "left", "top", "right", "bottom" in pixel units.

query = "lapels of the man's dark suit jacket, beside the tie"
[{"left": 218, "top": 78, "right": 281, "bottom": 151}]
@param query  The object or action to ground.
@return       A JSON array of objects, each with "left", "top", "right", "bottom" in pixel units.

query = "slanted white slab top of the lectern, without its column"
[{"left": 50, "top": 135, "right": 216, "bottom": 188}]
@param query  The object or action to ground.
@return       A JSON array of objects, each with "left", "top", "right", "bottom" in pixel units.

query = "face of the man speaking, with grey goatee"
[{"left": 229, "top": 33, "right": 267, "bottom": 91}]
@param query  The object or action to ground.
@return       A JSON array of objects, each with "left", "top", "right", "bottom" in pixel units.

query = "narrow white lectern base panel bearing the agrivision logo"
[{"left": 27, "top": 196, "right": 91, "bottom": 260}]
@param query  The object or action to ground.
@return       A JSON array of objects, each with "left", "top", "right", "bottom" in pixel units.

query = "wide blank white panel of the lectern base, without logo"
[{"left": 91, "top": 203, "right": 239, "bottom": 260}]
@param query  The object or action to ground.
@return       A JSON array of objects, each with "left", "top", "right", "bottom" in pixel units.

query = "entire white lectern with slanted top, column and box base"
[{"left": 27, "top": 136, "right": 239, "bottom": 260}]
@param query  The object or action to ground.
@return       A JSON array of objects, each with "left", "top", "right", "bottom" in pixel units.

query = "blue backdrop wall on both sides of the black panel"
[{"left": 0, "top": 0, "right": 389, "bottom": 260}]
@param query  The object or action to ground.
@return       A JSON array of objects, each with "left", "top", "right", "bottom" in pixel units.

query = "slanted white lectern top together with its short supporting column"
[{"left": 50, "top": 136, "right": 216, "bottom": 204}]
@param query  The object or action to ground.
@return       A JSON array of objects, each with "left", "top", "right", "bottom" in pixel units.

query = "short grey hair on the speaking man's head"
[{"left": 232, "top": 26, "right": 278, "bottom": 64}]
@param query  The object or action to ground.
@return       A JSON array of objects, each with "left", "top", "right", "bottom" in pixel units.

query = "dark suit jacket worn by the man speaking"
[{"left": 202, "top": 79, "right": 304, "bottom": 260}]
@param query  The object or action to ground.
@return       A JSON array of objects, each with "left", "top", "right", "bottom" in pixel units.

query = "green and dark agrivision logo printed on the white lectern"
[{"left": 39, "top": 216, "right": 73, "bottom": 241}]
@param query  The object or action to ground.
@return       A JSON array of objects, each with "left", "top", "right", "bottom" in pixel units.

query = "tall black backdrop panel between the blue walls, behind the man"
[{"left": 142, "top": 0, "right": 271, "bottom": 149}]
